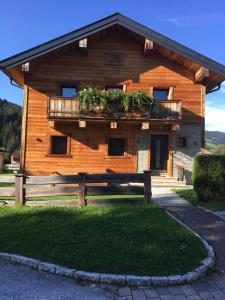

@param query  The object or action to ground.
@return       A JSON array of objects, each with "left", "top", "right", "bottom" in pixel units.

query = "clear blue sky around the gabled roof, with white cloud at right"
[{"left": 0, "top": 0, "right": 225, "bottom": 132}]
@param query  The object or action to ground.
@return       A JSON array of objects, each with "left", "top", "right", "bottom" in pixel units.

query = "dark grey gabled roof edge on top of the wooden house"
[{"left": 0, "top": 13, "right": 225, "bottom": 76}]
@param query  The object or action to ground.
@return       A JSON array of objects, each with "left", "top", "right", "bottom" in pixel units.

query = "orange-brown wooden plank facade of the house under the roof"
[{"left": 0, "top": 14, "right": 225, "bottom": 176}]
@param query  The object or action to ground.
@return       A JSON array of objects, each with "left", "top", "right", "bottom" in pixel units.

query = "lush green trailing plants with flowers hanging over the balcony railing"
[{"left": 78, "top": 87, "right": 154, "bottom": 113}]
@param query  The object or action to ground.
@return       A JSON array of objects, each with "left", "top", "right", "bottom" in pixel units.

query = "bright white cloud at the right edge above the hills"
[{"left": 205, "top": 105, "right": 225, "bottom": 132}]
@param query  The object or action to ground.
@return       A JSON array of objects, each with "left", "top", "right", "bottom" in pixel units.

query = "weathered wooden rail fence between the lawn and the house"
[{"left": 0, "top": 171, "right": 151, "bottom": 206}]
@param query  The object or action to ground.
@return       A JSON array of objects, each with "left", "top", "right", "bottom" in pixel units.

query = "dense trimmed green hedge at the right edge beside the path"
[{"left": 193, "top": 155, "right": 225, "bottom": 202}]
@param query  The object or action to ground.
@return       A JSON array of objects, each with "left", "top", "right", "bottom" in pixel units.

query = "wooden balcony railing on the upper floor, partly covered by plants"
[{"left": 48, "top": 97, "right": 182, "bottom": 121}]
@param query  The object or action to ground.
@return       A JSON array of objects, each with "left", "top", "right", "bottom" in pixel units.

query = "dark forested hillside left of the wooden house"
[{"left": 0, "top": 98, "right": 22, "bottom": 161}]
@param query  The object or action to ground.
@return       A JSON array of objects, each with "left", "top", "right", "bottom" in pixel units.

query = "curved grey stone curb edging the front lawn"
[{"left": 0, "top": 211, "right": 215, "bottom": 287}]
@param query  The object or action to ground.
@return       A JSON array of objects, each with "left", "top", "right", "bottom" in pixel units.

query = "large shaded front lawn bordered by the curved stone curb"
[{"left": 0, "top": 205, "right": 206, "bottom": 275}]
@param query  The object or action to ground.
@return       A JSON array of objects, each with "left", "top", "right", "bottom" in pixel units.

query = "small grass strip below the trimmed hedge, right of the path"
[{"left": 173, "top": 189, "right": 225, "bottom": 211}]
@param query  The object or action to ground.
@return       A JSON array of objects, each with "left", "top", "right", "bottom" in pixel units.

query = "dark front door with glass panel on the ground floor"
[{"left": 151, "top": 134, "right": 168, "bottom": 170}]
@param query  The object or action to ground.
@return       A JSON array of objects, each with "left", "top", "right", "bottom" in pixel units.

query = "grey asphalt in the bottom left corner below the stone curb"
[{"left": 0, "top": 262, "right": 116, "bottom": 300}]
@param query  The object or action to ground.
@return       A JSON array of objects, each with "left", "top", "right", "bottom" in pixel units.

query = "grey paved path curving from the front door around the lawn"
[{"left": 115, "top": 188, "right": 225, "bottom": 300}]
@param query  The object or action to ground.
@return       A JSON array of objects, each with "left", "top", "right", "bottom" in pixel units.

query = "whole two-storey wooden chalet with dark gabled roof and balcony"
[{"left": 0, "top": 13, "right": 225, "bottom": 180}]
